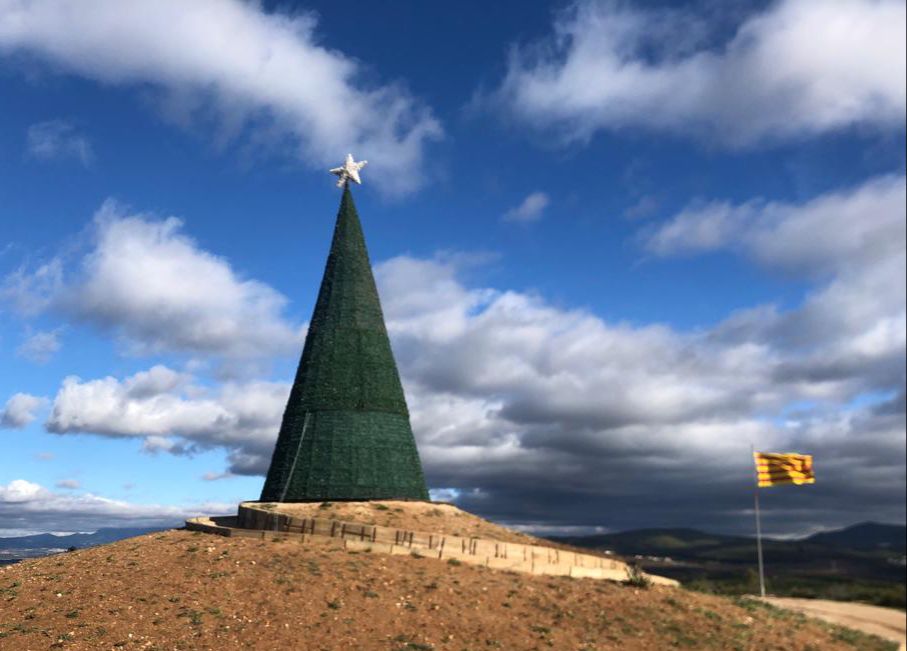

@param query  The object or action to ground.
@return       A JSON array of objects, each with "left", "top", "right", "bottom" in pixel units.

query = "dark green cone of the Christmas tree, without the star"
[{"left": 261, "top": 187, "right": 428, "bottom": 502}]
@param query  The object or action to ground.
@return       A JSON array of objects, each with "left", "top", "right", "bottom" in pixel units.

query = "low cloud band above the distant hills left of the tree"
[{"left": 0, "top": 479, "right": 236, "bottom": 534}]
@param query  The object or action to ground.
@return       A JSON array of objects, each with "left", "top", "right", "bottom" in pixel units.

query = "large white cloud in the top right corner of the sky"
[{"left": 496, "top": 0, "right": 907, "bottom": 146}]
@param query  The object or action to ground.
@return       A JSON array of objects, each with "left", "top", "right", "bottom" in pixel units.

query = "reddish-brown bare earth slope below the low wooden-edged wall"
[{"left": 0, "top": 531, "right": 890, "bottom": 651}]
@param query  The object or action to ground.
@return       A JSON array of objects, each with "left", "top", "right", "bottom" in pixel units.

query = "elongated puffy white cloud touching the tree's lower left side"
[{"left": 46, "top": 366, "right": 290, "bottom": 473}]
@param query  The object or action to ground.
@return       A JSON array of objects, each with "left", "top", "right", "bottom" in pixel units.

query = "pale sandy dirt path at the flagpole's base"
[{"left": 766, "top": 597, "right": 907, "bottom": 649}]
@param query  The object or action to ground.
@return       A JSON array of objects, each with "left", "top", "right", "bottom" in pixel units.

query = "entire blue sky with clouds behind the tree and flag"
[{"left": 0, "top": 0, "right": 905, "bottom": 535}]
